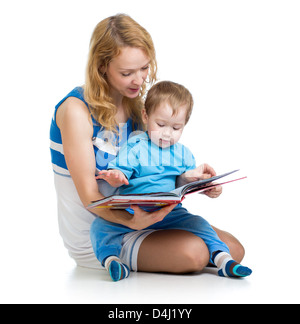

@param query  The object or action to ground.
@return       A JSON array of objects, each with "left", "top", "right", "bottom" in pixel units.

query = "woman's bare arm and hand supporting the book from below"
[{"left": 56, "top": 97, "right": 175, "bottom": 229}]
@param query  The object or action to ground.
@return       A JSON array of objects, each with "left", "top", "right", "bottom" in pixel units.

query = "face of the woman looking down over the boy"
[{"left": 102, "top": 47, "right": 150, "bottom": 98}]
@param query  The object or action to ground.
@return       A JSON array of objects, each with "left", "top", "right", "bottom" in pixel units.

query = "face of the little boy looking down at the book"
[{"left": 142, "top": 102, "right": 187, "bottom": 148}]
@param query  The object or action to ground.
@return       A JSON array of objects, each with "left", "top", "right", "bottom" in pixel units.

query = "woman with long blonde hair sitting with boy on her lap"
[{"left": 50, "top": 15, "right": 244, "bottom": 273}]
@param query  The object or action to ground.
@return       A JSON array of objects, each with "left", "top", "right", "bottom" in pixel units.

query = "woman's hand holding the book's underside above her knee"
[{"left": 127, "top": 204, "right": 177, "bottom": 230}]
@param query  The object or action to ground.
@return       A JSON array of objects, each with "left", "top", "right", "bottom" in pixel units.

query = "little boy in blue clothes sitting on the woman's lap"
[{"left": 91, "top": 81, "right": 252, "bottom": 281}]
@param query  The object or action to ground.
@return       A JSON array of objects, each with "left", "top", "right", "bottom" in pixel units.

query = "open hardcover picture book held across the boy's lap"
[{"left": 88, "top": 170, "right": 246, "bottom": 211}]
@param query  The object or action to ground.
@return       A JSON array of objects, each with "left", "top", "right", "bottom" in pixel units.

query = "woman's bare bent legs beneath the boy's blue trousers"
[{"left": 138, "top": 227, "right": 245, "bottom": 273}]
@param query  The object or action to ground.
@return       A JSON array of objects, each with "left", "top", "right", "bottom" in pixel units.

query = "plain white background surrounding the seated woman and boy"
[{"left": 0, "top": 0, "right": 300, "bottom": 303}]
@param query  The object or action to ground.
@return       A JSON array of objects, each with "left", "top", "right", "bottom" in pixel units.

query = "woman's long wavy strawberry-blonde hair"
[{"left": 84, "top": 14, "right": 157, "bottom": 132}]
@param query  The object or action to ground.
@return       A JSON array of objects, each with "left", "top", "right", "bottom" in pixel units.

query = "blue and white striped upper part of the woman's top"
[{"left": 50, "top": 87, "right": 133, "bottom": 177}]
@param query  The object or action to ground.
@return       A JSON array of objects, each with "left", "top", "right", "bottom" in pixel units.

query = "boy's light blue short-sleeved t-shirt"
[{"left": 108, "top": 133, "right": 196, "bottom": 194}]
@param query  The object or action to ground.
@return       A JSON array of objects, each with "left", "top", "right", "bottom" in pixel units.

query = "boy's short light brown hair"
[{"left": 145, "top": 81, "right": 194, "bottom": 124}]
